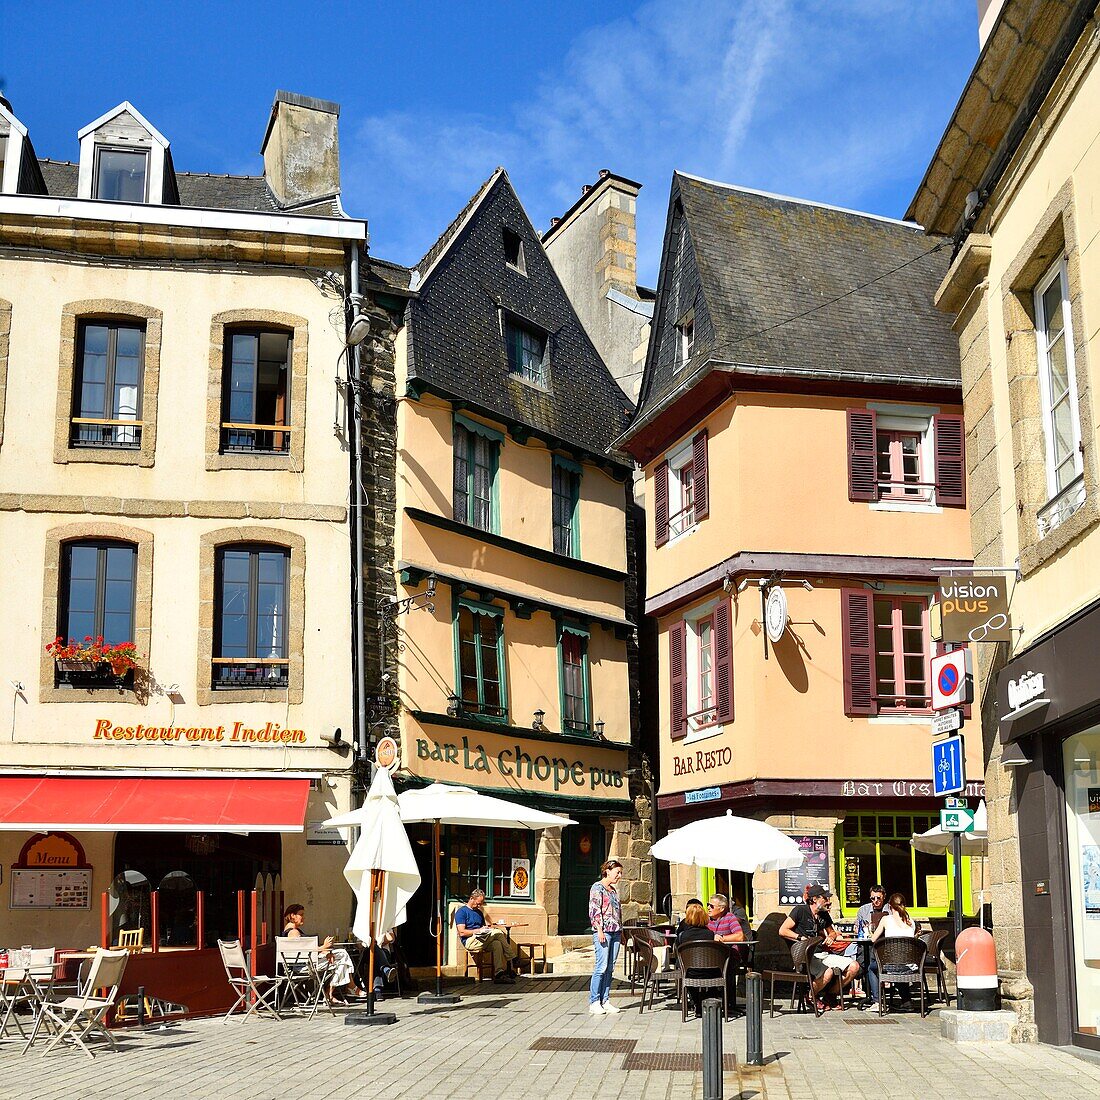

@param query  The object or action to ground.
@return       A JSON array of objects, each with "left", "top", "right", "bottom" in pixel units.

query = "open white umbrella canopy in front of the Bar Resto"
[{"left": 650, "top": 810, "right": 805, "bottom": 873}]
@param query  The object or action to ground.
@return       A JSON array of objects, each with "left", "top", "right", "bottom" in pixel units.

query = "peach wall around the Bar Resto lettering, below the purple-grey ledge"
[{"left": 657, "top": 583, "right": 983, "bottom": 796}]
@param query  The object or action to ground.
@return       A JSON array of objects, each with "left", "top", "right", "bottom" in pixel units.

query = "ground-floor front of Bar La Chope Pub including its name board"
[{"left": 395, "top": 713, "right": 641, "bottom": 965}]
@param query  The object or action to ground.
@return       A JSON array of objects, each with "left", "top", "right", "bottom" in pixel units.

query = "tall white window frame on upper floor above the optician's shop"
[{"left": 1034, "top": 256, "right": 1085, "bottom": 535}]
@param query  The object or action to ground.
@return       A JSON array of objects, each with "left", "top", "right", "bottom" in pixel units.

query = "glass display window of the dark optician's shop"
[{"left": 1063, "top": 729, "right": 1100, "bottom": 1035}]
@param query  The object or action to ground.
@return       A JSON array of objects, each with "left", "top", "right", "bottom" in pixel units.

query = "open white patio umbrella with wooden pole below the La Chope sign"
[{"left": 397, "top": 783, "right": 576, "bottom": 1003}]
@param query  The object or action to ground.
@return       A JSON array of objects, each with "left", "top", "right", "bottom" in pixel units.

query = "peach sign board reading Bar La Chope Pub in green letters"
[{"left": 402, "top": 728, "right": 629, "bottom": 802}]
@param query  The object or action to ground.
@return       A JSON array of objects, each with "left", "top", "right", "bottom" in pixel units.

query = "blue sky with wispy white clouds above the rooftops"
[{"left": 0, "top": 0, "right": 978, "bottom": 284}]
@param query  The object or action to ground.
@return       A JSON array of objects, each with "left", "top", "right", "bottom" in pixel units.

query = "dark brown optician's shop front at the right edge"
[{"left": 997, "top": 605, "right": 1100, "bottom": 1051}]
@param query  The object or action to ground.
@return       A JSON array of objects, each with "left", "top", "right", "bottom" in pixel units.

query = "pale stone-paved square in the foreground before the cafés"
[{"left": 0, "top": 977, "right": 1100, "bottom": 1100}]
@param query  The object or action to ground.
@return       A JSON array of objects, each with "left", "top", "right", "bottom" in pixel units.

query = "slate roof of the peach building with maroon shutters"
[{"left": 636, "top": 173, "right": 959, "bottom": 422}]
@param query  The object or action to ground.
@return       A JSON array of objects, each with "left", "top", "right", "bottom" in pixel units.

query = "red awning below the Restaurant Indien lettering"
[{"left": 0, "top": 776, "right": 309, "bottom": 833}]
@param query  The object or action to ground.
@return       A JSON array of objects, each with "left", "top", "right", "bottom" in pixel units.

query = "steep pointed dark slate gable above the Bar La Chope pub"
[{"left": 408, "top": 168, "right": 629, "bottom": 461}]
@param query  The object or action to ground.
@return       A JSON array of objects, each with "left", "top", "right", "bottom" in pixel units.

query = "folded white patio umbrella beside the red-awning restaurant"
[{"left": 326, "top": 768, "right": 420, "bottom": 1020}]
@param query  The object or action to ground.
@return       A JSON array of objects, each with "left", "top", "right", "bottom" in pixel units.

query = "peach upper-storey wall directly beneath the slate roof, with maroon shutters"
[{"left": 646, "top": 393, "right": 970, "bottom": 596}]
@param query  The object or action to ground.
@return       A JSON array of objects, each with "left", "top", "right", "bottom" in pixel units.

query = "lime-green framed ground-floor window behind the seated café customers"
[{"left": 836, "top": 812, "right": 974, "bottom": 917}]
